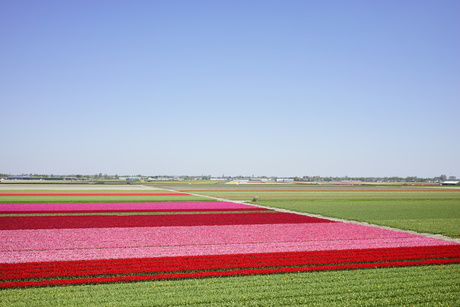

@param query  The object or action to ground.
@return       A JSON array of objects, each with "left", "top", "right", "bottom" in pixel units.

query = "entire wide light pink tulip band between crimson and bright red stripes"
[{"left": 0, "top": 223, "right": 457, "bottom": 263}]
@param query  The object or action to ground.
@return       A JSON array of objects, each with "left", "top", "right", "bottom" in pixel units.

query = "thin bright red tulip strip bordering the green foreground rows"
[{"left": 0, "top": 258, "right": 460, "bottom": 288}]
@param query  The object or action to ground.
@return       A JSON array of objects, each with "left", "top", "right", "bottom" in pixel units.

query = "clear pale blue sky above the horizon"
[{"left": 0, "top": 0, "right": 460, "bottom": 177}]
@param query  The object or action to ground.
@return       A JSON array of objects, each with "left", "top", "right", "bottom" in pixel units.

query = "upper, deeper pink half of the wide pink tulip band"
[{"left": 0, "top": 223, "right": 451, "bottom": 254}]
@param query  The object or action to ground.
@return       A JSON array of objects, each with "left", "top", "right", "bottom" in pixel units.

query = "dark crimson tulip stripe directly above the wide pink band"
[{"left": 0, "top": 211, "right": 335, "bottom": 230}]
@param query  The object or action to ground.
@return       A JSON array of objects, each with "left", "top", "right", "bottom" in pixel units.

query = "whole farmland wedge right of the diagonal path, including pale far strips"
[{"left": 180, "top": 186, "right": 460, "bottom": 238}]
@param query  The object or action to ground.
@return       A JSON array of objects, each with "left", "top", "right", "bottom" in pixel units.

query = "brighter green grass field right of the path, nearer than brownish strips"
[{"left": 258, "top": 198, "right": 460, "bottom": 238}]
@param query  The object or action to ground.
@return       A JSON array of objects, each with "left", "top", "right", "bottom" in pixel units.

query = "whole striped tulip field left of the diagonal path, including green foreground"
[{"left": 0, "top": 185, "right": 460, "bottom": 306}]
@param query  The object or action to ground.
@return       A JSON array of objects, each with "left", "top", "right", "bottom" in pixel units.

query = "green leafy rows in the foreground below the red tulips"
[{"left": 0, "top": 265, "right": 460, "bottom": 307}]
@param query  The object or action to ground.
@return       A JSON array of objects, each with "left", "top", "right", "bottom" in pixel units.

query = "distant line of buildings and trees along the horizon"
[{"left": 0, "top": 173, "right": 460, "bottom": 185}]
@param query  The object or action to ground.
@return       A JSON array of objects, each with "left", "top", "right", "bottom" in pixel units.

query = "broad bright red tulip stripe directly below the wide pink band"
[{"left": 0, "top": 245, "right": 460, "bottom": 279}]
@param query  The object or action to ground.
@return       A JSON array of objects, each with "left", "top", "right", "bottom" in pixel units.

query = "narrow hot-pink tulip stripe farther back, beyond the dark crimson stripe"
[{"left": 0, "top": 202, "right": 258, "bottom": 213}]
